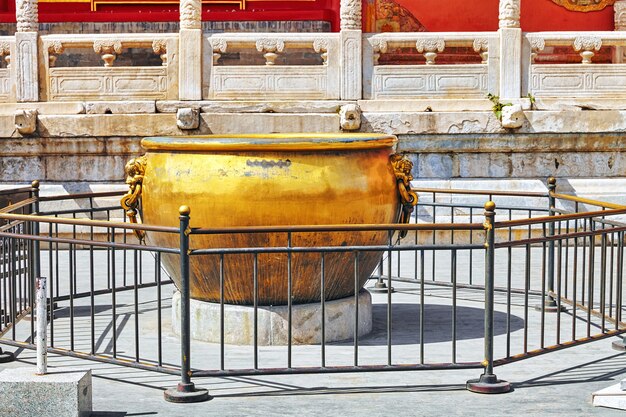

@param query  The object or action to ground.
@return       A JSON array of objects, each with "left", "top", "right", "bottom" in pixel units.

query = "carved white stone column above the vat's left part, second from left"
[{"left": 178, "top": 0, "right": 202, "bottom": 100}]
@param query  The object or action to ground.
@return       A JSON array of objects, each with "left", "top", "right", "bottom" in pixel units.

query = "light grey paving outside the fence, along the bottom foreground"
[{"left": 0, "top": 341, "right": 626, "bottom": 417}]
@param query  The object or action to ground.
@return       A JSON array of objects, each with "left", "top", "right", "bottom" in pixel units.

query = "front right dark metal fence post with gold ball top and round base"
[{"left": 466, "top": 201, "right": 511, "bottom": 394}]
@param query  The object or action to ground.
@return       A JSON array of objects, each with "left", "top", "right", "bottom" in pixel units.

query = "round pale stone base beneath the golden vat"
[{"left": 172, "top": 290, "right": 372, "bottom": 346}]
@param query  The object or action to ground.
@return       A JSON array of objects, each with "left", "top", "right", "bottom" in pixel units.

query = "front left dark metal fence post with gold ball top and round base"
[{"left": 163, "top": 206, "right": 209, "bottom": 403}]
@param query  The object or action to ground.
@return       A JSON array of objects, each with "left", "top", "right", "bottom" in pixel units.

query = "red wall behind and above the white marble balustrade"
[{"left": 0, "top": 0, "right": 613, "bottom": 32}]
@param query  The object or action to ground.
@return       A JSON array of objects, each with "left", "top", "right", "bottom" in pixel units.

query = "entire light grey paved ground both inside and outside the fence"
[{"left": 0, "top": 245, "right": 626, "bottom": 417}]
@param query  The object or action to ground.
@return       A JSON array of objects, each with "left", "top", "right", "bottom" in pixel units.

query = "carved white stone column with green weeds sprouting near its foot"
[{"left": 498, "top": 0, "right": 522, "bottom": 99}]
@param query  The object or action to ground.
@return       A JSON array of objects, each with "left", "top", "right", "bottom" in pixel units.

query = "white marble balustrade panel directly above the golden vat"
[{"left": 203, "top": 33, "right": 341, "bottom": 100}]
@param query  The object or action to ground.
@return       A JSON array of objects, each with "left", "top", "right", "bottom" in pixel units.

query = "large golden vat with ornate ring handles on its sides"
[{"left": 123, "top": 134, "right": 416, "bottom": 305}]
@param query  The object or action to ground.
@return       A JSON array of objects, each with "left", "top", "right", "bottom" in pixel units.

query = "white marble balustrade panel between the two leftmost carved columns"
[{"left": 39, "top": 34, "right": 178, "bottom": 101}]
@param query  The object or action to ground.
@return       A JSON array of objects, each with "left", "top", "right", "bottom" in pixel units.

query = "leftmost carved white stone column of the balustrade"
[{"left": 12, "top": 0, "right": 39, "bottom": 102}]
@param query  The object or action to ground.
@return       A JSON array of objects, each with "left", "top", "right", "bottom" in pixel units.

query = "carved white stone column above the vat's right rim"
[{"left": 340, "top": 0, "right": 363, "bottom": 100}]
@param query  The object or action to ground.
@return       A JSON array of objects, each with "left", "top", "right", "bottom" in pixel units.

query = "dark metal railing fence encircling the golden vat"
[{"left": 0, "top": 180, "right": 626, "bottom": 401}]
